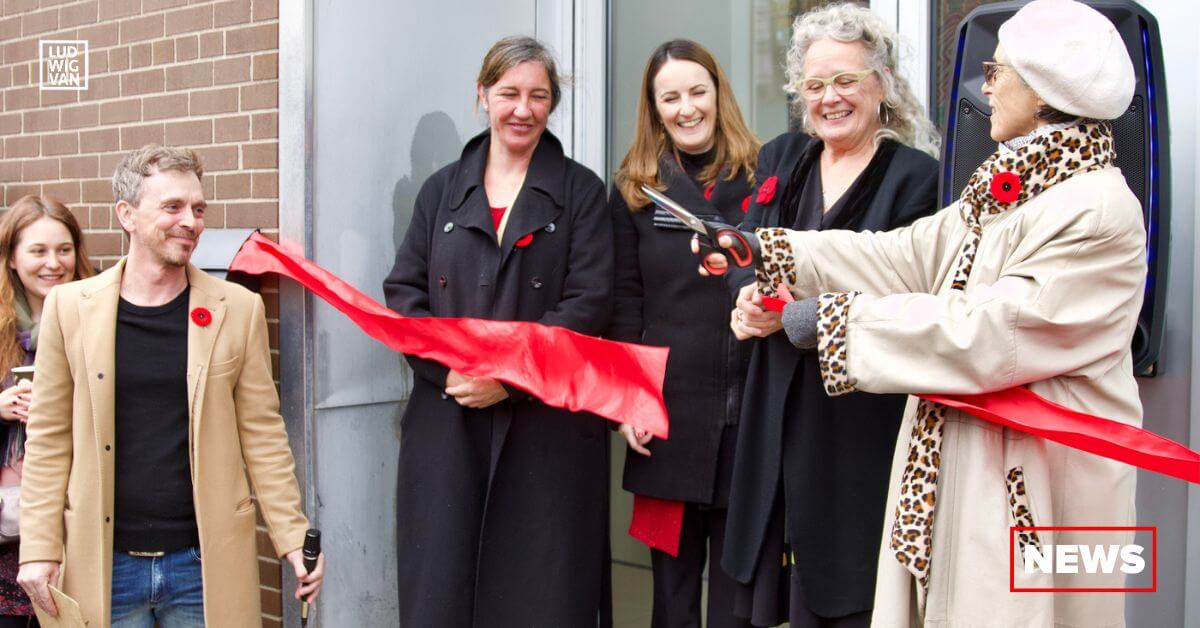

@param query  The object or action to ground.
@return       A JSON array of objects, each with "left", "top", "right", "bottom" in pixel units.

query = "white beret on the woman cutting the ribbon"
[{"left": 1000, "top": 0, "right": 1135, "bottom": 120}]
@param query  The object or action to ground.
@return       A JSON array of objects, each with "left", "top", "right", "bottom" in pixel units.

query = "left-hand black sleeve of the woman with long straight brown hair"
[{"left": 605, "top": 185, "right": 644, "bottom": 342}]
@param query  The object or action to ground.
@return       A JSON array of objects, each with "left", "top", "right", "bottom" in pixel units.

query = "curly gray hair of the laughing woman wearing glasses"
[{"left": 784, "top": 2, "right": 941, "bottom": 157}]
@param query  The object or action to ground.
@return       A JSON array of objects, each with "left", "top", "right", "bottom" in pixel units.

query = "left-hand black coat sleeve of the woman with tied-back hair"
[{"left": 383, "top": 175, "right": 450, "bottom": 388}]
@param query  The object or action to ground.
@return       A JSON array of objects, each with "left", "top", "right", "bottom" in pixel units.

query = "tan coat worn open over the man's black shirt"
[{"left": 20, "top": 259, "right": 307, "bottom": 628}]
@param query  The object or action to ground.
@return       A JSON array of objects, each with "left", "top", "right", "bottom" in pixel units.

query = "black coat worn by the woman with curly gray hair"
[{"left": 721, "top": 133, "right": 937, "bottom": 617}]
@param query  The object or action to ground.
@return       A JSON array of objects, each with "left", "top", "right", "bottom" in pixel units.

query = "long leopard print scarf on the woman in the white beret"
[{"left": 888, "top": 124, "right": 1115, "bottom": 605}]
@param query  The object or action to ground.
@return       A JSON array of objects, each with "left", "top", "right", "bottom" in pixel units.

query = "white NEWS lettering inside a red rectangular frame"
[{"left": 1008, "top": 526, "right": 1158, "bottom": 593}]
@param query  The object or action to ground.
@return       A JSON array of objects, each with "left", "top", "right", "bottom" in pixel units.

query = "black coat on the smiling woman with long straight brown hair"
[{"left": 608, "top": 157, "right": 750, "bottom": 507}]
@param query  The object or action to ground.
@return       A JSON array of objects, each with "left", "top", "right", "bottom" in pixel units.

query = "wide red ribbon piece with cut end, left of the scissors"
[{"left": 229, "top": 232, "right": 667, "bottom": 438}]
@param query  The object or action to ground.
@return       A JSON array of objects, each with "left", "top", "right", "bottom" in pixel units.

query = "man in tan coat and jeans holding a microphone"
[{"left": 18, "top": 145, "right": 323, "bottom": 628}]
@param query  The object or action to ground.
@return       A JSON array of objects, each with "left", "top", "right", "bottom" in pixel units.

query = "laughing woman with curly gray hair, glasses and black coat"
[{"left": 722, "top": 2, "right": 937, "bottom": 627}]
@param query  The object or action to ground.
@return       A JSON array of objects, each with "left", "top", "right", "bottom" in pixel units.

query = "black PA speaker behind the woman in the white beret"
[{"left": 940, "top": 0, "right": 1171, "bottom": 377}]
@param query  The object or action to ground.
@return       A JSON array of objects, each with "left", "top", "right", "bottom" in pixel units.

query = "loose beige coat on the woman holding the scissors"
[{"left": 772, "top": 168, "right": 1148, "bottom": 628}]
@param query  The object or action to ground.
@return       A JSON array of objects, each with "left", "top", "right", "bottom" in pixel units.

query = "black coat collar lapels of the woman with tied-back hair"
[{"left": 450, "top": 130, "right": 566, "bottom": 211}]
